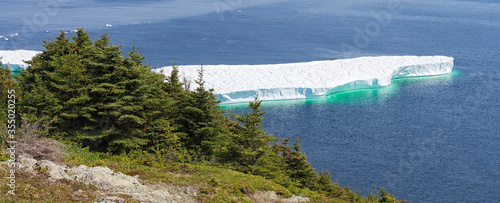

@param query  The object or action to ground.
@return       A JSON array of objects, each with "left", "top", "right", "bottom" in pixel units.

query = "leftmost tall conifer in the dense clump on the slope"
[{"left": 19, "top": 32, "right": 89, "bottom": 136}]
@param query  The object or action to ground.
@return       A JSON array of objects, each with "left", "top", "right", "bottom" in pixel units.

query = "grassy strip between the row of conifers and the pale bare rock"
[{"left": 65, "top": 144, "right": 396, "bottom": 202}]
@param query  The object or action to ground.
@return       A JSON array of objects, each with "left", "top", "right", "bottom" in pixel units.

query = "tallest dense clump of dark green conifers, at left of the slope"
[{"left": 19, "top": 29, "right": 181, "bottom": 152}]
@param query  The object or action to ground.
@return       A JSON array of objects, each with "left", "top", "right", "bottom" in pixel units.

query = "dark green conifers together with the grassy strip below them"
[{"left": 0, "top": 29, "right": 399, "bottom": 202}]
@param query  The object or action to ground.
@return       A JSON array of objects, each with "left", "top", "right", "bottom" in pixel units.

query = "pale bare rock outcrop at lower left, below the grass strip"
[{"left": 12, "top": 156, "right": 195, "bottom": 203}]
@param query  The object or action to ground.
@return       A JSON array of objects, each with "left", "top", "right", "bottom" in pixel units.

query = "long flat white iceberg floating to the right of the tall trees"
[{"left": 154, "top": 56, "right": 454, "bottom": 103}]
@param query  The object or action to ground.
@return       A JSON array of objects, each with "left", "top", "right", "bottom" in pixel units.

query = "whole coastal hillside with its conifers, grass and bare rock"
[{"left": 0, "top": 29, "right": 399, "bottom": 202}]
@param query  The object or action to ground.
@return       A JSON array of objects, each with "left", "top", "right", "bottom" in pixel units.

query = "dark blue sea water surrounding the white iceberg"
[{"left": 0, "top": 0, "right": 500, "bottom": 202}]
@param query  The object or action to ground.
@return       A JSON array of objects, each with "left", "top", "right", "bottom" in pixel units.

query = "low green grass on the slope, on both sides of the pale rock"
[{"left": 0, "top": 146, "right": 398, "bottom": 202}]
